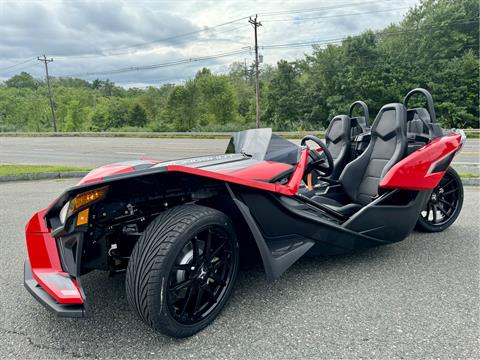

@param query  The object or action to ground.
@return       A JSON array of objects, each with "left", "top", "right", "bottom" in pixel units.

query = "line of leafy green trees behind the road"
[{"left": 0, "top": 0, "right": 480, "bottom": 132}]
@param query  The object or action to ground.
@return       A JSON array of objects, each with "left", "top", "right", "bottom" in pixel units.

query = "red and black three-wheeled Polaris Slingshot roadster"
[{"left": 24, "top": 89, "right": 465, "bottom": 337}]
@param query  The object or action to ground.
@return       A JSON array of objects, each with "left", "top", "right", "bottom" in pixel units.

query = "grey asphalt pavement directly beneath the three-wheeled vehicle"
[{"left": 0, "top": 180, "right": 480, "bottom": 359}]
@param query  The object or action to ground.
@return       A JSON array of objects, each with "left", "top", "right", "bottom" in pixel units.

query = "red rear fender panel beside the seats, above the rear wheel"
[{"left": 379, "top": 134, "right": 462, "bottom": 190}]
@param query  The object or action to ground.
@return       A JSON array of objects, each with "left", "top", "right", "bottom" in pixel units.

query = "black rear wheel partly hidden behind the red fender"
[{"left": 416, "top": 167, "right": 463, "bottom": 232}]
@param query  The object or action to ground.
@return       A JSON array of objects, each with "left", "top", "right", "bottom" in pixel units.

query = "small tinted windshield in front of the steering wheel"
[{"left": 225, "top": 128, "right": 300, "bottom": 165}]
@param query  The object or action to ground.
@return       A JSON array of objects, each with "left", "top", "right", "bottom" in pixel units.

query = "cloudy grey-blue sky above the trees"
[{"left": 0, "top": 0, "right": 419, "bottom": 87}]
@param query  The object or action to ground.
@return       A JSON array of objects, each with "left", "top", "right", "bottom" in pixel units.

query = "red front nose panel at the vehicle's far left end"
[{"left": 25, "top": 209, "right": 83, "bottom": 304}]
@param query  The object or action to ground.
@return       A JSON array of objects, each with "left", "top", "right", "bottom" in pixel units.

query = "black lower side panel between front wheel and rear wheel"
[{"left": 227, "top": 185, "right": 430, "bottom": 280}]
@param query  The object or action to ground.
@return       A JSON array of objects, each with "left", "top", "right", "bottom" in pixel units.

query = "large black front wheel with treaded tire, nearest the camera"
[{"left": 126, "top": 205, "right": 239, "bottom": 338}]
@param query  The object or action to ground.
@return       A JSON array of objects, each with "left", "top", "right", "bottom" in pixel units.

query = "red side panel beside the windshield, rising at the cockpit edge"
[{"left": 167, "top": 149, "right": 308, "bottom": 196}]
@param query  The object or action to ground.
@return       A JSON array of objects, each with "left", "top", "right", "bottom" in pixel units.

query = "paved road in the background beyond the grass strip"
[{"left": 0, "top": 137, "right": 480, "bottom": 173}]
